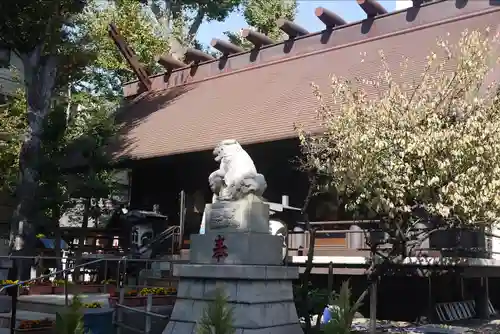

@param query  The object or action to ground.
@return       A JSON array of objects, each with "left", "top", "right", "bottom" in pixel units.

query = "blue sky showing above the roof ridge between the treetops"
[{"left": 197, "top": 0, "right": 396, "bottom": 49}]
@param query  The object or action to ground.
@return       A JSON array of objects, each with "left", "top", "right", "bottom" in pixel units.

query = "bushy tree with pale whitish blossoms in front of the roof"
[{"left": 298, "top": 30, "right": 500, "bottom": 254}]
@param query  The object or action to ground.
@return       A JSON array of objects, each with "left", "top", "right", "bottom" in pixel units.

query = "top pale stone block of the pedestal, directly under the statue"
[{"left": 205, "top": 194, "right": 269, "bottom": 234}]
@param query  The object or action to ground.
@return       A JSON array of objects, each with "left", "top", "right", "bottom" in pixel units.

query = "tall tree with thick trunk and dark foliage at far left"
[{"left": 0, "top": 0, "right": 91, "bottom": 276}]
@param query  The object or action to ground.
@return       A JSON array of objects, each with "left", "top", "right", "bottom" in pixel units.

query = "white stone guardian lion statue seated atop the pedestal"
[{"left": 208, "top": 139, "right": 267, "bottom": 202}]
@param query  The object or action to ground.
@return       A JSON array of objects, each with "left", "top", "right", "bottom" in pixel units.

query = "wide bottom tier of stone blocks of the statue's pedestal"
[{"left": 163, "top": 264, "right": 303, "bottom": 334}]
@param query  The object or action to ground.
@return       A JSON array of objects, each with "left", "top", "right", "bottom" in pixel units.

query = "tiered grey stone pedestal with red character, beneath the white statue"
[{"left": 163, "top": 195, "right": 303, "bottom": 334}]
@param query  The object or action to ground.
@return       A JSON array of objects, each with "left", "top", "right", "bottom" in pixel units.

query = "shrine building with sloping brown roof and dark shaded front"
[{"left": 111, "top": 0, "right": 500, "bottom": 227}]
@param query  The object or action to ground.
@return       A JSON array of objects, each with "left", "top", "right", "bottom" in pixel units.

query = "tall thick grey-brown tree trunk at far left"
[{"left": 10, "top": 46, "right": 57, "bottom": 279}]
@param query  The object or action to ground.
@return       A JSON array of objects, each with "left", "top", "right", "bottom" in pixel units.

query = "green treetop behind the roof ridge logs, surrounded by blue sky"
[{"left": 224, "top": 0, "right": 297, "bottom": 49}]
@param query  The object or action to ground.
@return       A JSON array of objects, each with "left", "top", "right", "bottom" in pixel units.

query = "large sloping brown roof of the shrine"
[{"left": 113, "top": 1, "right": 500, "bottom": 159}]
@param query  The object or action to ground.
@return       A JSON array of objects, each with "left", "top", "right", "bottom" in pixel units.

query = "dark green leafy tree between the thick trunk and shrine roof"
[{"left": 39, "top": 92, "right": 117, "bottom": 277}]
